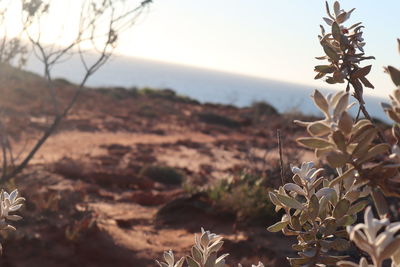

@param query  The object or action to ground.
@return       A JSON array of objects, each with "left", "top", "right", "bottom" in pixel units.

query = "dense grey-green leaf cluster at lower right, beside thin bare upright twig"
[{"left": 268, "top": 162, "right": 367, "bottom": 266}]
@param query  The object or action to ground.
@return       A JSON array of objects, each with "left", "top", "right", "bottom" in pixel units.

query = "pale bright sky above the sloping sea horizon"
[{"left": 2, "top": 0, "right": 400, "bottom": 96}]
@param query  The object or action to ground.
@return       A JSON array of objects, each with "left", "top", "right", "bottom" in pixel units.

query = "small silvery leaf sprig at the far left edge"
[{"left": 0, "top": 189, "right": 25, "bottom": 254}]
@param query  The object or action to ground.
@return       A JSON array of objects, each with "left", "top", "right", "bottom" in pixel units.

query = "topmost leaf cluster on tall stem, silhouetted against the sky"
[{"left": 314, "top": 1, "right": 374, "bottom": 103}]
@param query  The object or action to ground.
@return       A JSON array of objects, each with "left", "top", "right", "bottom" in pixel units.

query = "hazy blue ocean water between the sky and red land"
[{"left": 23, "top": 56, "right": 387, "bottom": 120}]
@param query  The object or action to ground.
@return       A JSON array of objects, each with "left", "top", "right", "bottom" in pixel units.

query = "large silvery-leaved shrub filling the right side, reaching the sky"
[{"left": 268, "top": 2, "right": 400, "bottom": 267}]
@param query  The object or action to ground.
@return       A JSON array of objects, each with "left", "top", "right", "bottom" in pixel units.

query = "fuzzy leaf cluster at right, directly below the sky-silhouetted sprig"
[{"left": 295, "top": 90, "right": 400, "bottom": 201}]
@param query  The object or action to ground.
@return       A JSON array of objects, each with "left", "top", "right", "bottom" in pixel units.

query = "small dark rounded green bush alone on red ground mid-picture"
[{"left": 139, "top": 165, "right": 184, "bottom": 185}]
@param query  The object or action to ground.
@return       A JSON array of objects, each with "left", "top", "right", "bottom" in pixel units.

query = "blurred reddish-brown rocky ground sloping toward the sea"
[{"left": 0, "top": 66, "right": 313, "bottom": 267}]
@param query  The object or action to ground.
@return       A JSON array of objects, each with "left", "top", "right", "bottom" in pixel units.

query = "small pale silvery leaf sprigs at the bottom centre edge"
[{"left": 156, "top": 228, "right": 264, "bottom": 267}]
